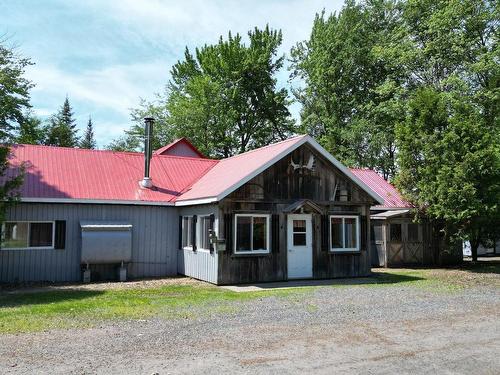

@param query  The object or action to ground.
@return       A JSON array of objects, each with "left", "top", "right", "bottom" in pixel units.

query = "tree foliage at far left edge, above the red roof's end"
[{"left": 0, "top": 39, "right": 34, "bottom": 143}]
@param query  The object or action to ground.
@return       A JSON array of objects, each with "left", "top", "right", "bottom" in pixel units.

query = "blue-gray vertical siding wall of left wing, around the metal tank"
[{"left": 0, "top": 203, "right": 178, "bottom": 282}]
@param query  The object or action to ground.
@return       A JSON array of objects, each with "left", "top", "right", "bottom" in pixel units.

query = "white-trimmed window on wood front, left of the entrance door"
[{"left": 234, "top": 214, "right": 270, "bottom": 254}]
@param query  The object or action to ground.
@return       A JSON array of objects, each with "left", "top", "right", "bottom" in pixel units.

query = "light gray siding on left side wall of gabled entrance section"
[{"left": 177, "top": 204, "right": 219, "bottom": 284}]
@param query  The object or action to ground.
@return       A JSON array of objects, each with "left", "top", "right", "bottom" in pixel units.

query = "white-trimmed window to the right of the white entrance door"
[{"left": 330, "top": 215, "right": 360, "bottom": 251}]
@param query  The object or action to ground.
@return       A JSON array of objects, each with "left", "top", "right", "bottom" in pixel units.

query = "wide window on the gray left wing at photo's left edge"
[{"left": 2, "top": 221, "right": 55, "bottom": 250}]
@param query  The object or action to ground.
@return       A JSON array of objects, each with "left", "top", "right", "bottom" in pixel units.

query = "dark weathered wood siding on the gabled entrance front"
[{"left": 218, "top": 145, "right": 374, "bottom": 284}]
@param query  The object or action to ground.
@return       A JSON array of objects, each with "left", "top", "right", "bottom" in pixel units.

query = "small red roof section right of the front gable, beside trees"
[{"left": 351, "top": 168, "right": 413, "bottom": 209}]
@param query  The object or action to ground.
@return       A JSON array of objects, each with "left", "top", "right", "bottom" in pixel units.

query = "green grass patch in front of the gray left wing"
[{"left": 0, "top": 284, "right": 299, "bottom": 333}]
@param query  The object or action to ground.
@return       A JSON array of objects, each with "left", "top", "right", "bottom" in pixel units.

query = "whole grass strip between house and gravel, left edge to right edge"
[{"left": 0, "top": 264, "right": 500, "bottom": 333}]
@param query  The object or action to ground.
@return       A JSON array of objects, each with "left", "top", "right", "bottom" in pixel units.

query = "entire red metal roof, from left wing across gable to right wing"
[{"left": 4, "top": 140, "right": 386, "bottom": 208}]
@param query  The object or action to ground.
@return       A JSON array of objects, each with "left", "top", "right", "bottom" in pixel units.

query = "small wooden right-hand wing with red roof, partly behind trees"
[{"left": 351, "top": 169, "right": 462, "bottom": 267}]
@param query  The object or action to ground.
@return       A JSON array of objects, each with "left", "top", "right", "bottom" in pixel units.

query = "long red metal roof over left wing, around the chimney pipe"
[{"left": 5, "top": 145, "right": 217, "bottom": 202}]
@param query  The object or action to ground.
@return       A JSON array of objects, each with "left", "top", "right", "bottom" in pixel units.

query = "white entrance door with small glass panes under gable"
[{"left": 287, "top": 214, "right": 313, "bottom": 279}]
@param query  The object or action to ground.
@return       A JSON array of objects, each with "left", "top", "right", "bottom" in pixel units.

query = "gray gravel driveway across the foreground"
[{"left": 0, "top": 275, "right": 500, "bottom": 374}]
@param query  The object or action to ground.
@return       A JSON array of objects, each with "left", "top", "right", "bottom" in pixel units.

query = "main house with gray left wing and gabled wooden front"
[{"left": 0, "top": 135, "right": 384, "bottom": 284}]
